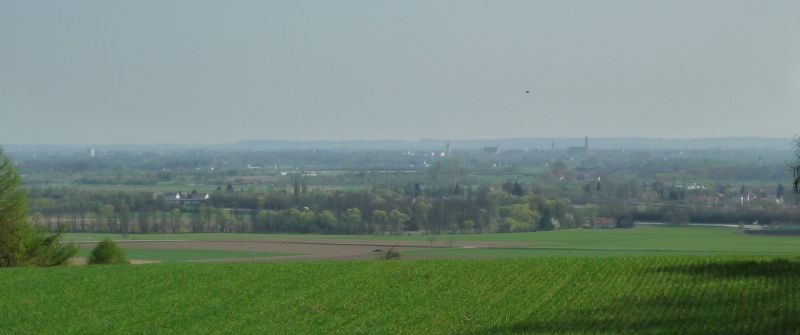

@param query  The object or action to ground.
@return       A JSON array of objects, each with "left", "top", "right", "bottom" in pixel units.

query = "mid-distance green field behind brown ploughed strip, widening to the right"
[{"left": 66, "top": 226, "right": 800, "bottom": 256}]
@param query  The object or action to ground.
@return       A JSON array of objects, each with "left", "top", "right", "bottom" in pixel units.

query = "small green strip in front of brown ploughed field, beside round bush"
[{"left": 73, "top": 248, "right": 296, "bottom": 263}]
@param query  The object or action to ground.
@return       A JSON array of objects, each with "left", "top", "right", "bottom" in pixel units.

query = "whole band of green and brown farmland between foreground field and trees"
[{"left": 66, "top": 225, "right": 800, "bottom": 261}]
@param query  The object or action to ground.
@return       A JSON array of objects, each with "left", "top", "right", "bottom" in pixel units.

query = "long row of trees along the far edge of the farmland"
[{"left": 25, "top": 172, "right": 800, "bottom": 234}]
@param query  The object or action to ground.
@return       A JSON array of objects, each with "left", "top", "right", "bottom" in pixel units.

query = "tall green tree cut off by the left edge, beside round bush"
[{"left": 0, "top": 150, "right": 78, "bottom": 267}]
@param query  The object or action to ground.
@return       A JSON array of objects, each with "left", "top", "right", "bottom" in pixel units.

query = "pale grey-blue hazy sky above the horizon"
[{"left": 0, "top": 0, "right": 800, "bottom": 144}]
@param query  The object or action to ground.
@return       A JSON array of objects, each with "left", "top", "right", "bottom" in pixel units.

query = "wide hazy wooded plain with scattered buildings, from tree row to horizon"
[{"left": 13, "top": 142, "right": 800, "bottom": 240}]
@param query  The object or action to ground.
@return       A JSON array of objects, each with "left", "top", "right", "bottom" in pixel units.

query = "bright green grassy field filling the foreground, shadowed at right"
[{"left": 0, "top": 257, "right": 800, "bottom": 334}]
